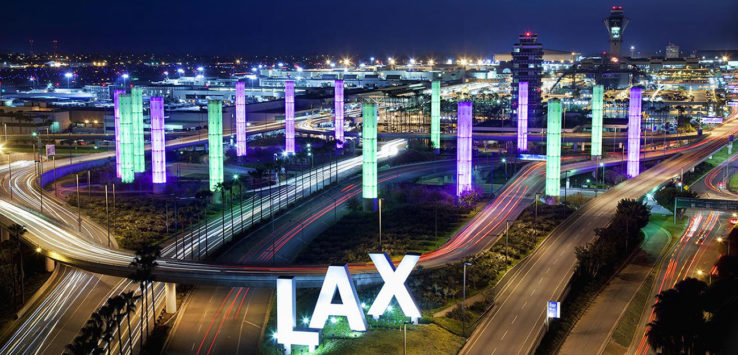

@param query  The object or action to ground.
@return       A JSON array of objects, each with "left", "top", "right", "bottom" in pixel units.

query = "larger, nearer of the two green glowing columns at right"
[{"left": 546, "top": 99, "right": 561, "bottom": 198}]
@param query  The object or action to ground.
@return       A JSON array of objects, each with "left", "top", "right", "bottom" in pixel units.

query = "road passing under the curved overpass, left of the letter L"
[{"left": 165, "top": 160, "right": 455, "bottom": 354}]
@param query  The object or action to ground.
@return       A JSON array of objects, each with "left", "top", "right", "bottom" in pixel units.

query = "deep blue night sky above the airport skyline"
[{"left": 0, "top": 0, "right": 738, "bottom": 56}]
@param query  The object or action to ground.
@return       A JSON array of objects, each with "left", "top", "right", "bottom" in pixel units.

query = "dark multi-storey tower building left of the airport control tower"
[{"left": 510, "top": 32, "right": 543, "bottom": 127}]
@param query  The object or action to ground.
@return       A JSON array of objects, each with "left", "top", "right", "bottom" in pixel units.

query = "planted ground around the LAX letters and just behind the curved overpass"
[{"left": 261, "top": 185, "right": 572, "bottom": 354}]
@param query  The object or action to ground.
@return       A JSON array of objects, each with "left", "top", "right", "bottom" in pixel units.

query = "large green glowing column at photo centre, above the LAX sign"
[{"left": 361, "top": 103, "right": 377, "bottom": 198}]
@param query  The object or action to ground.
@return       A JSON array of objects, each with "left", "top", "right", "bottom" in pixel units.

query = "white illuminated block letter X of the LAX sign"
[{"left": 368, "top": 253, "right": 421, "bottom": 323}]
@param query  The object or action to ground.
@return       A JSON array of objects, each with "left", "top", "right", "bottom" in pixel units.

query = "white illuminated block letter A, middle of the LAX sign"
[{"left": 310, "top": 264, "right": 366, "bottom": 332}]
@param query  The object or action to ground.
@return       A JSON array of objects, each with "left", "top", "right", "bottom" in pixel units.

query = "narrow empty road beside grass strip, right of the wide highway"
[{"left": 559, "top": 223, "right": 671, "bottom": 354}]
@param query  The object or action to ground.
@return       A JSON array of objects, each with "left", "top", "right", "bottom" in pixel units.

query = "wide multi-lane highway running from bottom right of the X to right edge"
[{"left": 460, "top": 115, "right": 737, "bottom": 354}]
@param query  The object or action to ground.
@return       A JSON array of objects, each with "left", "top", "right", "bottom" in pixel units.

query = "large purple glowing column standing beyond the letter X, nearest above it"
[{"left": 456, "top": 102, "right": 472, "bottom": 196}]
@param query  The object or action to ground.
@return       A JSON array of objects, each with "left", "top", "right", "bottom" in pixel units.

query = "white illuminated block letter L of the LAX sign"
[{"left": 276, "top": 276, "right": 319, "bottom": 354}]
